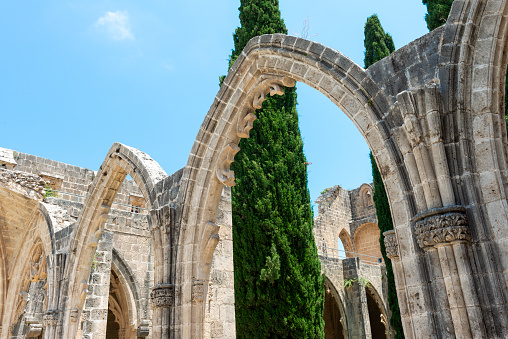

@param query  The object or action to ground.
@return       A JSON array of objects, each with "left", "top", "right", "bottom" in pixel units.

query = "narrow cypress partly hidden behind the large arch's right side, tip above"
[{"left": 364, "top": 14, "right": 404, "bottom": 339}]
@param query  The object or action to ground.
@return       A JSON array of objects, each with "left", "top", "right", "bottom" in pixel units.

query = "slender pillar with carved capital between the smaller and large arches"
[{"left": 150, "top": 206, "right": 175, "bottom": 339}]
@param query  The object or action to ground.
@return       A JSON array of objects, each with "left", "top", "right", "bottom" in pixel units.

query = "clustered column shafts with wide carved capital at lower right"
[{"left": 412, "top": 206, "right": 486, "bottom": 338}]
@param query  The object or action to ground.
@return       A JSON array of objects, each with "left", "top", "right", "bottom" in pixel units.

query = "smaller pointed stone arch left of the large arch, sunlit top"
[{"left": 62, "top": 143, "right": 167, "bottom": 337}]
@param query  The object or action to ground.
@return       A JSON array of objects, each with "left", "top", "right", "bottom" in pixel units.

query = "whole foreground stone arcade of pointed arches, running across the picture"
[{"left": 0, "top": 0, "right": 508, "bottom": 338}]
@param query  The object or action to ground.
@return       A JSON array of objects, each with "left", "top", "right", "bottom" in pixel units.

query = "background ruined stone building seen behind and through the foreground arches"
[{"left": 0, "top": 148, "right": 389, "bottom": 339}]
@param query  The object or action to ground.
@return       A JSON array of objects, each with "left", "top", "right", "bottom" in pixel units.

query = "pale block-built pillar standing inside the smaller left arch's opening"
[{"left": 82, "top": 231, "right": 113, "bottom": 339}]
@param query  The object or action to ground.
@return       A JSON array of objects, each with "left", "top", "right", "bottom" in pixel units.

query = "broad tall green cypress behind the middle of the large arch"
[{"left": 230, "top": 0, "right": 324, "bottom": 338}]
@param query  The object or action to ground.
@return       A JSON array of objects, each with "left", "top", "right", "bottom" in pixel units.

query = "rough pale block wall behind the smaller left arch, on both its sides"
[{"left": 0, "top": 149, "right": 154, "bottom": 338}]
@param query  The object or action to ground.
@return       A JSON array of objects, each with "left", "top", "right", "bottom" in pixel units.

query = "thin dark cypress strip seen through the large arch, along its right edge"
[{"left": 370, "top": 153, "right": 404, "bottom": 339}]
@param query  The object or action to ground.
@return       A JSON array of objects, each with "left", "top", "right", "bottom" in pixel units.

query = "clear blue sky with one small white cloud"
[{"left": 0, "top": 0, "right": 428, "bottom": 207}]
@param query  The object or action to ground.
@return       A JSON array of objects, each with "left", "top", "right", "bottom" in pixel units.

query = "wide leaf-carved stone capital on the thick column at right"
[{"left": 412, "top": 206, "right": 471, "bottom": 249}]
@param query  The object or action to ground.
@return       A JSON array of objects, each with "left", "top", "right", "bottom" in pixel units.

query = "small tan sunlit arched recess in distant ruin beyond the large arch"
[{"left": 353, "top": 222, "right": 382, "bottom": 264}]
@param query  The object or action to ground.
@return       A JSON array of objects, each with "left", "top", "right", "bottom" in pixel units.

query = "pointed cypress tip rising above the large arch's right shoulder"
[{"left": 363, "top": 14, "right": 395, "bottom": 68}]
